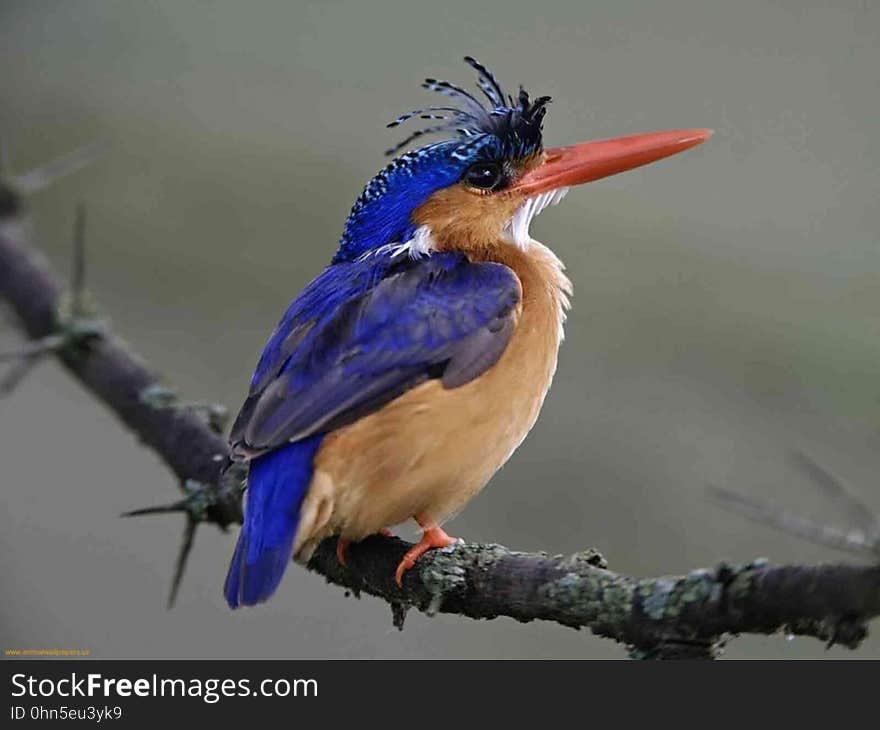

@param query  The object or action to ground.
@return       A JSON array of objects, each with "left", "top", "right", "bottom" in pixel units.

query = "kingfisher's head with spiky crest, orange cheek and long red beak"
[{"left": 334, "top": 56, "right": 711, "bottom": 262}]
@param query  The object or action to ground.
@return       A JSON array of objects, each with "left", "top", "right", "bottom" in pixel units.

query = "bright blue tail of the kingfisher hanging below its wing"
[{"left": 223, "top": 434, "right": 323, "bottom": 608}]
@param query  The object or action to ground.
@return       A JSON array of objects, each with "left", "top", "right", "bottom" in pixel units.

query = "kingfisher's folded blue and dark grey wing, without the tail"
[{"left": 231, "top": 253, "right": 521, "bottom": 458}]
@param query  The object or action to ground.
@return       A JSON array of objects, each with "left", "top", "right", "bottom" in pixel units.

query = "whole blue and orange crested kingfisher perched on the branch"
[{"left": 224, "top": 56, "right": 711, "bottom": 608}]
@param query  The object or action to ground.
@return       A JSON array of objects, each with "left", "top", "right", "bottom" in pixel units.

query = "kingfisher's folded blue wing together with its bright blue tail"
[{"left": 225, "top": 247, "right": 520, "bottom": 608}]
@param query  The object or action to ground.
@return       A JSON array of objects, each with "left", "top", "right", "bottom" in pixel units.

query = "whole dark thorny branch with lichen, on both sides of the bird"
[{"left": 0, "top": 168, "right": 880, "bottom": 658}]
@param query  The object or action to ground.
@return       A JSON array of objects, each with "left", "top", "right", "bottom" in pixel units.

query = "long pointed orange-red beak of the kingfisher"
[{"left": 512, "top": 129, "right": 712, "bottom": 197}]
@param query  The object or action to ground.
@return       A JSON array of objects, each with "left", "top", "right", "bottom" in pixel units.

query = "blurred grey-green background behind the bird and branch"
[{"left": 0, "top": 0, "right": 880, "bottom": 658}]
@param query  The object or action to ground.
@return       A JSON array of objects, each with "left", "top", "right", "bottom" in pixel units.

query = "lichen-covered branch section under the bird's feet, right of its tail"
[{"left": 309, "top": 536, "right": 880, "bottom": 657}]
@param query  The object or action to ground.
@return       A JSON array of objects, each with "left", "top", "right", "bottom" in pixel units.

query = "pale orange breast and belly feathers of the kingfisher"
[{"left": 294, "top": 242, "right": 571, "bottom": 560}]
